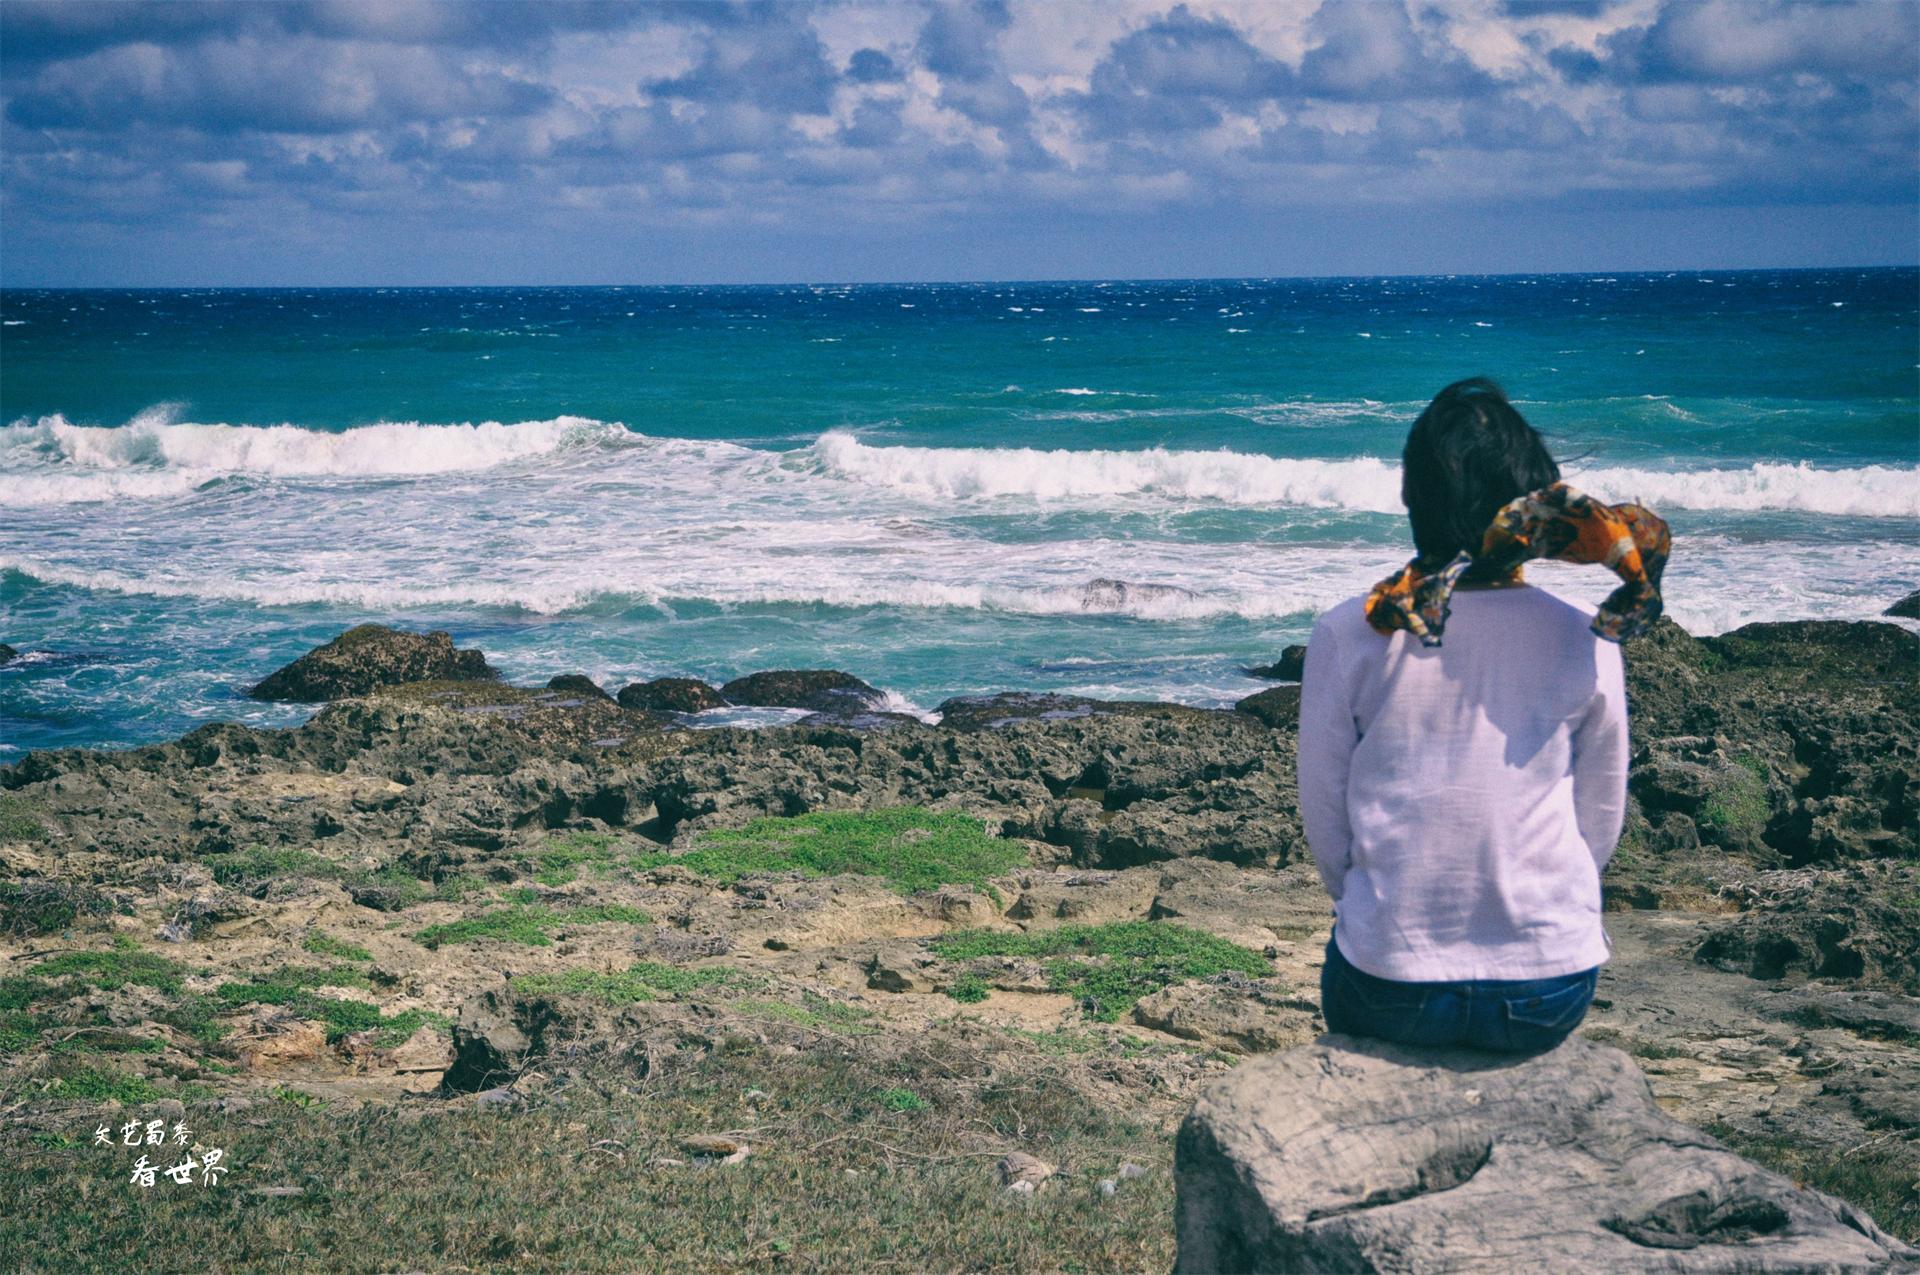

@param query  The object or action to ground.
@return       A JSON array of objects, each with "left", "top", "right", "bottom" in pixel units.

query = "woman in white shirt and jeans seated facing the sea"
[{"left": 1300, "top": 378, "right": 1668, "bottom": 1052}]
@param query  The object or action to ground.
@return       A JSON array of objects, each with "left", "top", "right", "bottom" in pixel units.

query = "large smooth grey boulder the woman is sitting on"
[{"left": 1175, "top": 1037, "right": 1920, "bottom": 1275}]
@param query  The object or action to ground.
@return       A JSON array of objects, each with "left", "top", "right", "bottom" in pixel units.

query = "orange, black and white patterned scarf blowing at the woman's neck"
[{"left": 1367, "top": 482, "right": 1672, "bottom": 647}]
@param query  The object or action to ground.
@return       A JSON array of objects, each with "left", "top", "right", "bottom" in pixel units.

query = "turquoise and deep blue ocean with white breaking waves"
[{"left": 0, "top": 269, "right": 1920, "bottom": 748}]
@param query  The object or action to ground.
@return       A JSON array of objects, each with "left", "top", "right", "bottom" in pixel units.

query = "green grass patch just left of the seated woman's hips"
[{"left": 929, "top": 922, "right": 1273, "bottom": 1023}]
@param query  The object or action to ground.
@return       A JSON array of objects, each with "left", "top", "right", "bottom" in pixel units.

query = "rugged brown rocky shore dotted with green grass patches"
[{"left": 0, "top": 610, "right": 1920, "bottom": 1269}]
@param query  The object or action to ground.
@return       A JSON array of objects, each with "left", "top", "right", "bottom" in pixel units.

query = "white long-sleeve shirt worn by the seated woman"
[{"left": 1300, "top": 586, "right": 1626, "bottom": 983}]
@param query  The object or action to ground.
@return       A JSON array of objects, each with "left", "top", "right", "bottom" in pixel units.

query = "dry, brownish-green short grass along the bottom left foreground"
[{"left": 0, "top": 1039, "right": 1173, "bottom": 1273}]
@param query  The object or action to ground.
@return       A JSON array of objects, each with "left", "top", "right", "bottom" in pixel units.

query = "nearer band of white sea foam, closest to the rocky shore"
[{"left": 0, "top": 536, "right": 1916, "bottom": 634}]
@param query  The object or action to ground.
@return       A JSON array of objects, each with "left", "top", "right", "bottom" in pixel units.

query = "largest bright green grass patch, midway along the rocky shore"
[{"left": 632, "top": 806, "right": 1027, "bottom": 895}]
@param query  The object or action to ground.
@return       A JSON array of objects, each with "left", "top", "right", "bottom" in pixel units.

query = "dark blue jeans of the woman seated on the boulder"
[{"left": 1321, "top": 939, "right": 1599, "bottom": 1054}]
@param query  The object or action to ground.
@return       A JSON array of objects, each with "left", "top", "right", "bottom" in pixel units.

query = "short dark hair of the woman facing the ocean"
[{"left": 1400, "top": 376, "right": 1559, "bottom": 566}]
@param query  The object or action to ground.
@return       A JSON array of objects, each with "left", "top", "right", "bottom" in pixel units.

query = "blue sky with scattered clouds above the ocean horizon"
[{"left": 0, "top": 0, "right": 1920, "bottom": 288}]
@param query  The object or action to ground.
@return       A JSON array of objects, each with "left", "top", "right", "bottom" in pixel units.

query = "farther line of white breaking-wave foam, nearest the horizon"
[{"left": 0, "top": 416, "right": 1920, "bottom": 518}]
